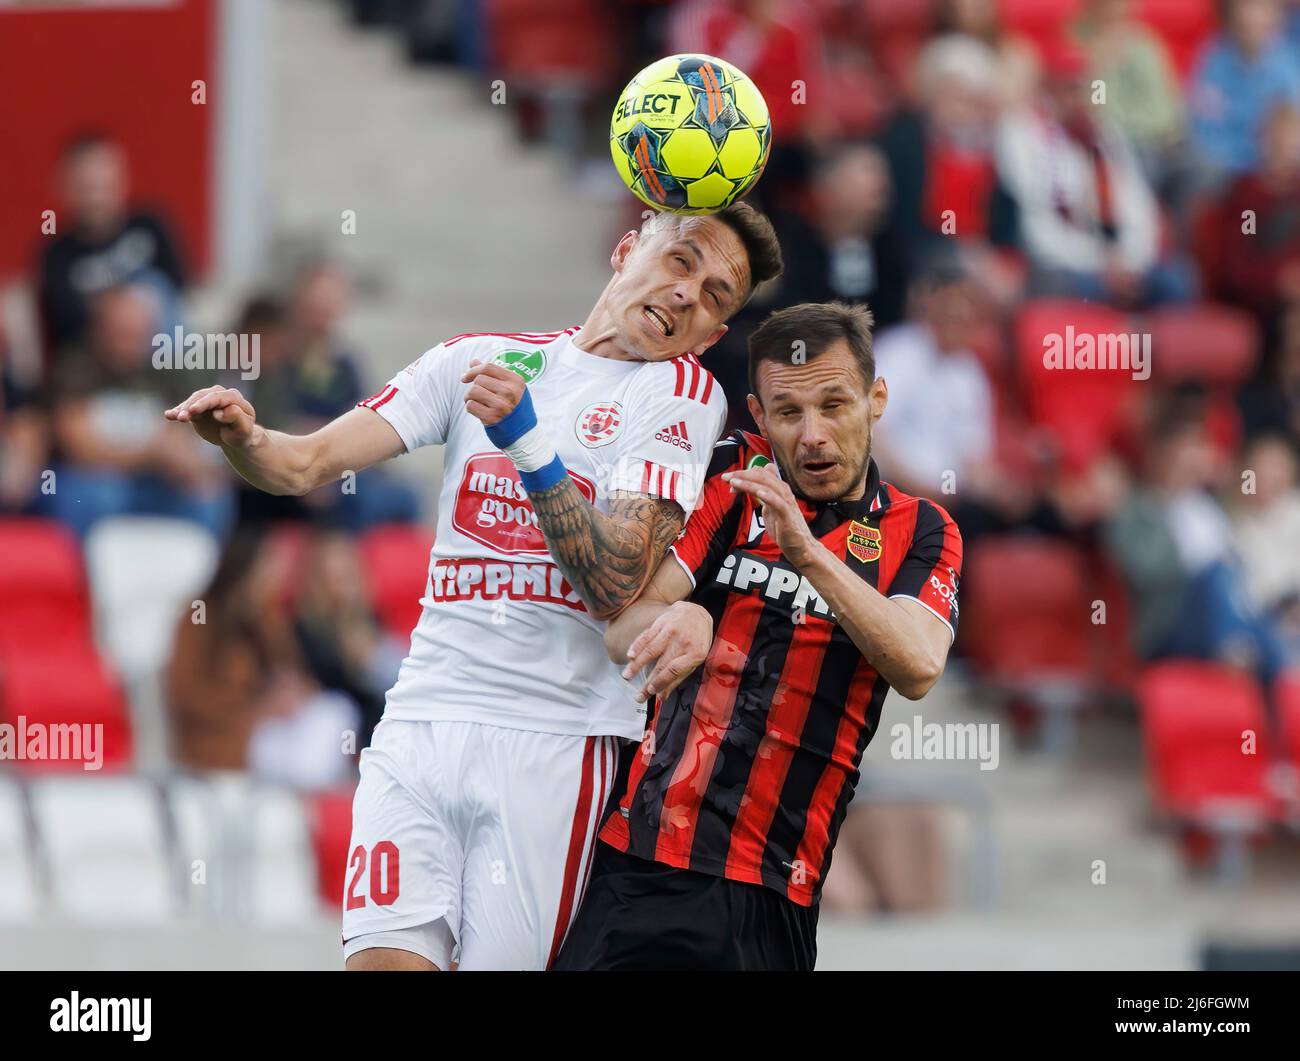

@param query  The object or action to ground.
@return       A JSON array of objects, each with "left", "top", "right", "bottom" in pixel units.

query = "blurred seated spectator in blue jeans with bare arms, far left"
[{"left": 42, "top": 285, "right": 231, "bottom": 534}]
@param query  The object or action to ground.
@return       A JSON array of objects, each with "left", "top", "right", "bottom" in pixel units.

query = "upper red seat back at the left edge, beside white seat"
[{"left": 0, "top": 519, "right": 90, "bottom": 659}]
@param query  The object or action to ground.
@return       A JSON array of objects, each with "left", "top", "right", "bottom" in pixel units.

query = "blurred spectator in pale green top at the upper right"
[{"left": 1075, "top": 0, "right": 1186, "bottom": 189}]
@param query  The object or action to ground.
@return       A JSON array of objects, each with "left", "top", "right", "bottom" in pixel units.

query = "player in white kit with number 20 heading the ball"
[{"left": 166, "top": 204, "right": 780, "bottom": 969}]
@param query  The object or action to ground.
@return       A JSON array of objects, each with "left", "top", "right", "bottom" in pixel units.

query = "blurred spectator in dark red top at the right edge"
[{"left": 1205, "top": 103, "right": 1300, "bottom": 324}]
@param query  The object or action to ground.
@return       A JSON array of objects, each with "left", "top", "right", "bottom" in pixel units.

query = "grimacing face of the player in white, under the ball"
[{"left": 606, "top": 218, "right": 749, "bottom": 361}]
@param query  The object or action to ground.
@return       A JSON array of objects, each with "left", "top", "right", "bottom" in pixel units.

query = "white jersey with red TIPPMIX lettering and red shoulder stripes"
[{"left": 361, "top": 328, "right": 727, "bottom": 740}]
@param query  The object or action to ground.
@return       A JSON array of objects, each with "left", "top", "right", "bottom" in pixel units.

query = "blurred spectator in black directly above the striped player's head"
[{"left": 776, "top": 144, "right": 907, "bottom": 329}]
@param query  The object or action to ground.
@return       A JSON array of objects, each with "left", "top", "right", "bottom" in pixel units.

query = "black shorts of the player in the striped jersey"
[{"left": 551, "top": 843, "right": 818, "bottom": 971}]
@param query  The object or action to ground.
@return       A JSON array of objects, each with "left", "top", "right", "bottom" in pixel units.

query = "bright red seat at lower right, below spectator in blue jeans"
[{"left": 1138, "top": 662, "right": 1275, "bottom": 826}]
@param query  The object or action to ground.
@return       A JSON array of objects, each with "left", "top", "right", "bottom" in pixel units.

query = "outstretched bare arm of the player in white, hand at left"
[{"left": 163, "top": 386, "right": 406, "bottom": 494}]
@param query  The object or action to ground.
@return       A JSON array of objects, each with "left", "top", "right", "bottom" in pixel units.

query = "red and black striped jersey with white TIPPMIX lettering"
[{"left": 601, "top": 432, "right": 962, "bottom": 906}]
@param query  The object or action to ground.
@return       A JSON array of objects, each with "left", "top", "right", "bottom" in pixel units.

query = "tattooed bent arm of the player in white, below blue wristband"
[{"left": 529, "top": 478, "right": 685, "bottom": 619}]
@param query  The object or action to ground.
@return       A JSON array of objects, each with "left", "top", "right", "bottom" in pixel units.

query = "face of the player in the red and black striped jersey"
[{"left": 749, "top": 339, "right": 889, "bottom": 503}]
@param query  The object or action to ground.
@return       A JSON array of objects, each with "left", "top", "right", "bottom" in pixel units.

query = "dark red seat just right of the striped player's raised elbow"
[{"left": 961, "top": 537, "right": 1092, "bottom": 688}]
